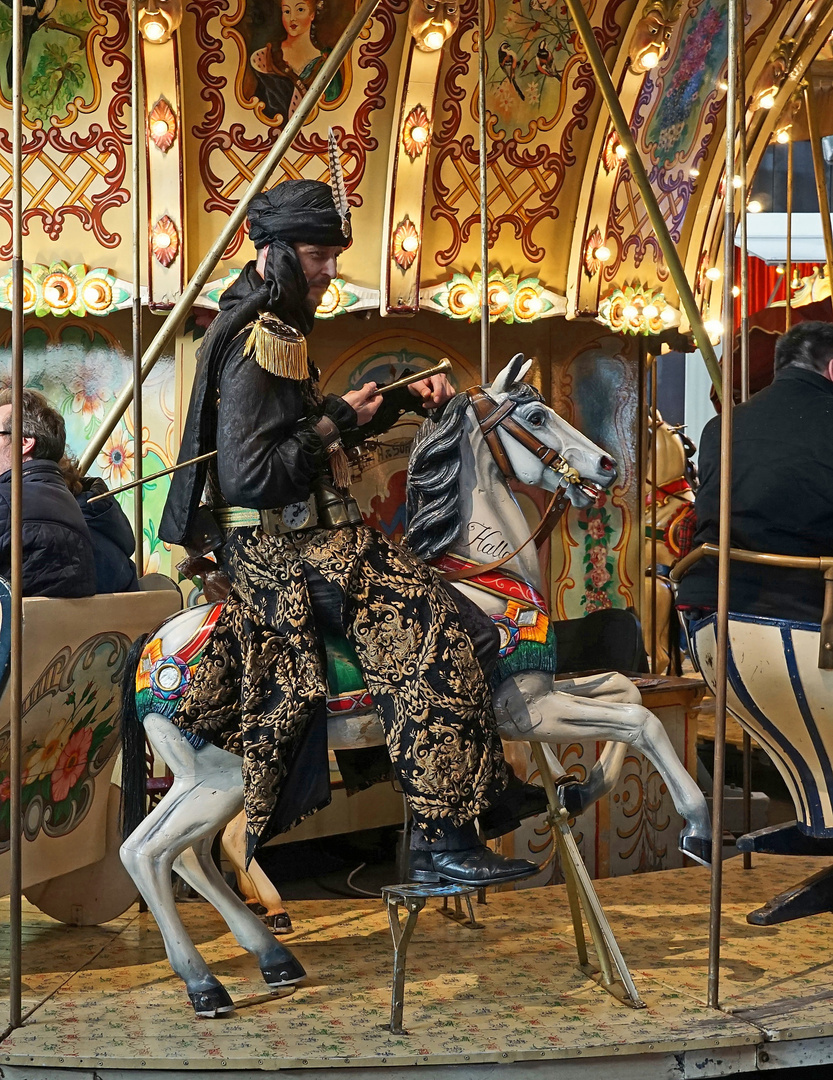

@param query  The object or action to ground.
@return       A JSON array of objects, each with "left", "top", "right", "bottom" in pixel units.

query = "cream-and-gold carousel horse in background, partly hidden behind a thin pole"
[{"left": 642, "top": 410, "right": 697, "bottom": 675}]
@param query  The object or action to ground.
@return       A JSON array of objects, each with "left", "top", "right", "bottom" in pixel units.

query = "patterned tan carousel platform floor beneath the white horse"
[{"left": 0, "top": 856, "right": 833, "bottom": 1080}]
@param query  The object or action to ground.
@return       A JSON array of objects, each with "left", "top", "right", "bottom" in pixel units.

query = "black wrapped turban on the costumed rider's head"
[{"left": 248, "top": 180, "right": 351, "bottom": 248}]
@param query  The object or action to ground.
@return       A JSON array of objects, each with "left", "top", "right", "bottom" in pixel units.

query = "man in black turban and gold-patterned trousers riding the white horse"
[{"left": 159, "top": 174, "right": 546, "bottom": 886}]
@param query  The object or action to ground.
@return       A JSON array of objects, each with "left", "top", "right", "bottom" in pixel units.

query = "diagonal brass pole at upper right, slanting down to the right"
[{"left": 565, "top": 0, "right": 723, "bottom": 397}]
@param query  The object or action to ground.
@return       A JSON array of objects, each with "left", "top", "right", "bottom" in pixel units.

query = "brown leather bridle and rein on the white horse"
[{"left": 443, "top": 387, "right": 581, "bottom": 581}]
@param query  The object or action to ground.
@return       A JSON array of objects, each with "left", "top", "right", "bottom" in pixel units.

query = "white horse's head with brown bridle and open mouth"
[{"left": 487, "top": 353, "right": 617, "bottom": 508}]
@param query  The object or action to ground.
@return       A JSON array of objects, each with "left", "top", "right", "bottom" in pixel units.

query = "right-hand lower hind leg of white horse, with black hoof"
[{"left": 174, "top": 836, "right": 306, "bottom": 989}]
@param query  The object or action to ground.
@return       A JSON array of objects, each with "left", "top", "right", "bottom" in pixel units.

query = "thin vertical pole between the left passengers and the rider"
[{"left": 130, "top": 0, "right": 145, "bottom": 577}]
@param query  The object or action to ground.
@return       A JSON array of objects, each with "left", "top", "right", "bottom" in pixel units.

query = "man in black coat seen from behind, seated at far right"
[{"left": 677, "top": 322, "right": 833, "bottom": 622}]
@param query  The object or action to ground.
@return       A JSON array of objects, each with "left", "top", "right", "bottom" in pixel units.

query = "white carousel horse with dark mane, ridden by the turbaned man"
[{"left": 122, "top": 355, "right": 711, "bottom": 1016}]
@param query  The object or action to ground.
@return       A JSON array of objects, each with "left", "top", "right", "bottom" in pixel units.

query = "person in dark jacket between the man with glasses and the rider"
[{"left": 58, "top": 455, "right": 138, "bottom": 593}]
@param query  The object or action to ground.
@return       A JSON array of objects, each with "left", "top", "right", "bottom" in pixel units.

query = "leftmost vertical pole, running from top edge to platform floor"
[{"left": 9, "top": 0, "right": 24, "bottom": 1028}]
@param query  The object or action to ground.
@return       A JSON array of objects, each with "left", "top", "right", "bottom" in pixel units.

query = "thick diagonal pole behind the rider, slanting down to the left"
[{"left": 79, "top": 0, "right": 380, "bottom": 473}]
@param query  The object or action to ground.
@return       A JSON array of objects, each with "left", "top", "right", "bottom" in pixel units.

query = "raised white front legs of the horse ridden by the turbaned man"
[{"left": 494, "top": 672, "right": 711, "bottom": 864}]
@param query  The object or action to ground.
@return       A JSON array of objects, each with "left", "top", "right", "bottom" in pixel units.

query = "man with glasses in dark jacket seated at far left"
[{"left": 0, "top": 390, "right": 95, "bottom": 596}]
